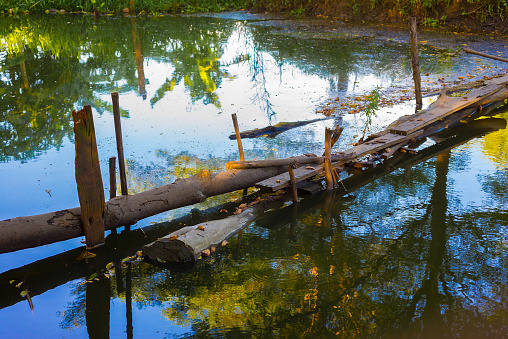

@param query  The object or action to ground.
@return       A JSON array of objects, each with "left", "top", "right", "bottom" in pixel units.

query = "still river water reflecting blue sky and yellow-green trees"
[{"left": 0, "top": 13, "right": 508, "bottom": 338}]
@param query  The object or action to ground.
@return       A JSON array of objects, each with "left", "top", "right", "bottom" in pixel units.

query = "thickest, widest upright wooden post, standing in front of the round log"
[{"left": 72, "top": 105, "right": 106, "bottom": 248}]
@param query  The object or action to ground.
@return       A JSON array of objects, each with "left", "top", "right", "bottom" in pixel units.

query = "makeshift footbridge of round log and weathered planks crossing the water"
[{"left": 0, "top": 75, "right": 508, "bottom": 253}]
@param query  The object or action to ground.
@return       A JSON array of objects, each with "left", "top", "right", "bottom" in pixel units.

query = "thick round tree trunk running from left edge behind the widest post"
[{"left": 0, "top": 166, "right": 287, "bottom": 253}]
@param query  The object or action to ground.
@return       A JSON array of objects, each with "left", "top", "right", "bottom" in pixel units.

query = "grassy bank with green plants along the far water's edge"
[{"left": 0, "top": 0, "right": 508, "bottom": 29}]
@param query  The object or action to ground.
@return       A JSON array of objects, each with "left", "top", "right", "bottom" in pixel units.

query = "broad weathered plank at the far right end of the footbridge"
[{"left": 390, "top": 80, "right": 504, "bottom": 135}]
